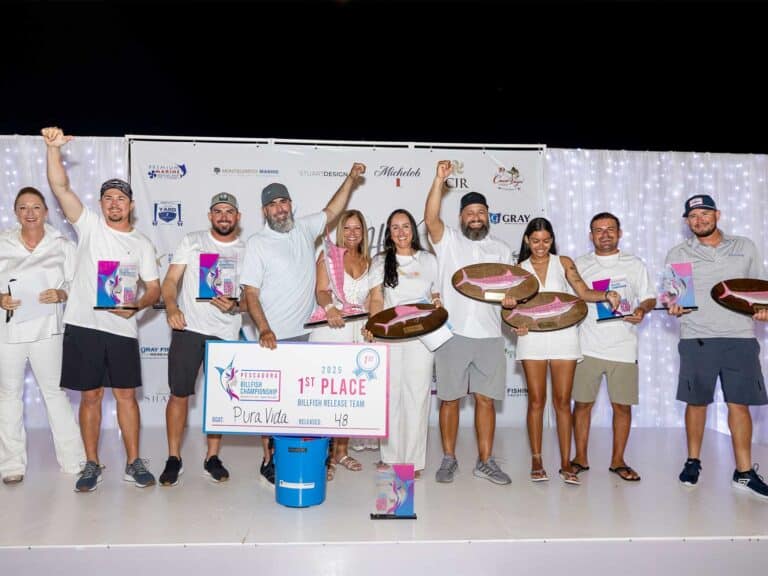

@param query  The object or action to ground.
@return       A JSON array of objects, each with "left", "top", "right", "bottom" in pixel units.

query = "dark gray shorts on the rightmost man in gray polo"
[{"left": 677, "top": 338, "right": 768, "bottom": 406}]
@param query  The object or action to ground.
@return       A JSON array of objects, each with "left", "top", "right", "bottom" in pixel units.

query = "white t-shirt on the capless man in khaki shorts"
[{"left": 576, "top": 252, "right": 656, "bottom": 362}]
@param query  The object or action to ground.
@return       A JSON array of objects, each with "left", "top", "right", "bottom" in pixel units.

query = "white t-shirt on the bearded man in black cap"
[{"left": 432, "top": 226, "right": 512, "bottom": 338}]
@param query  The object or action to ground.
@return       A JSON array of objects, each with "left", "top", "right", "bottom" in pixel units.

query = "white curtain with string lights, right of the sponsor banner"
[{"left": 544, "top": 149, "right": 768, "bottom": 442}]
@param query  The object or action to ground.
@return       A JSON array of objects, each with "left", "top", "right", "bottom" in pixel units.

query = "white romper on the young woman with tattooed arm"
[{"left": 516, "top": 254, "right": 582, "bottom": 360}]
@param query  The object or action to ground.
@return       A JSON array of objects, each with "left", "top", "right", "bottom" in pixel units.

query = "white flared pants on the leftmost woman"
[{"left": 0, "top": 334, "right": 85, "bottom": 476}]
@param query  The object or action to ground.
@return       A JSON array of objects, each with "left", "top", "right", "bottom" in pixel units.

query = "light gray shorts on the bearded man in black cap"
[{"left": 435, "top": 334, "right": 507, "bottom": 400}]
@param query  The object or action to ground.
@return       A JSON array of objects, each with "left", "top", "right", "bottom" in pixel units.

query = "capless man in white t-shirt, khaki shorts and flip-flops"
[{"left": 571, "top": 212, "right": 656, "bottom": 482}]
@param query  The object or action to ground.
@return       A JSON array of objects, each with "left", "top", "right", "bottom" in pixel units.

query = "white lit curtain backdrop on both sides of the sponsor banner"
[{"left": 0, "top": 136, "right": 768, "bottom": 442}]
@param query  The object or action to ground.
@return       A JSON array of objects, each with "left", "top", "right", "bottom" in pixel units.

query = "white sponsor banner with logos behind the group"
[{"left": 129, "top": 139, "right": 544, "bottom": 425}]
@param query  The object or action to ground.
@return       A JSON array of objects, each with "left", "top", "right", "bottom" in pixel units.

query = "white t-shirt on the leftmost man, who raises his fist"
[{"left": 64, "top": 206, "right": 158, "bottom": 338}]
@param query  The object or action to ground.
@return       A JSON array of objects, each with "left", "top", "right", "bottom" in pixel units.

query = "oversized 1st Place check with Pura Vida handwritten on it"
[{"left": 203, "top": 341, "right": 389, "bottom": 437}]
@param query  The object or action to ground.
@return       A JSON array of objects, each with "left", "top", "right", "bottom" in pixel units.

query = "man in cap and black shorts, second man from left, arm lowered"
[{"left": 160, "top": 192, "right": 245, "bottom": 486}]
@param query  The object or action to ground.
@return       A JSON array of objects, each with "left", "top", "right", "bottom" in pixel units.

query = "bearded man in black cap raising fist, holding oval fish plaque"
[{"left": 424, "top": 160, "right": 516, "bottom": 484}]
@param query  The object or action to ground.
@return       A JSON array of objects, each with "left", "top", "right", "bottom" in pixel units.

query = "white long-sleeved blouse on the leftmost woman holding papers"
[{"left": 0, "top": 224, "right": 75, "bottom": 344}]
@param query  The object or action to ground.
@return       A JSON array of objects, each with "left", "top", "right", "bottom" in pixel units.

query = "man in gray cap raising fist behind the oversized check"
[{"left": 240, "top": 162, "right": 365, "bottom": 484}]
